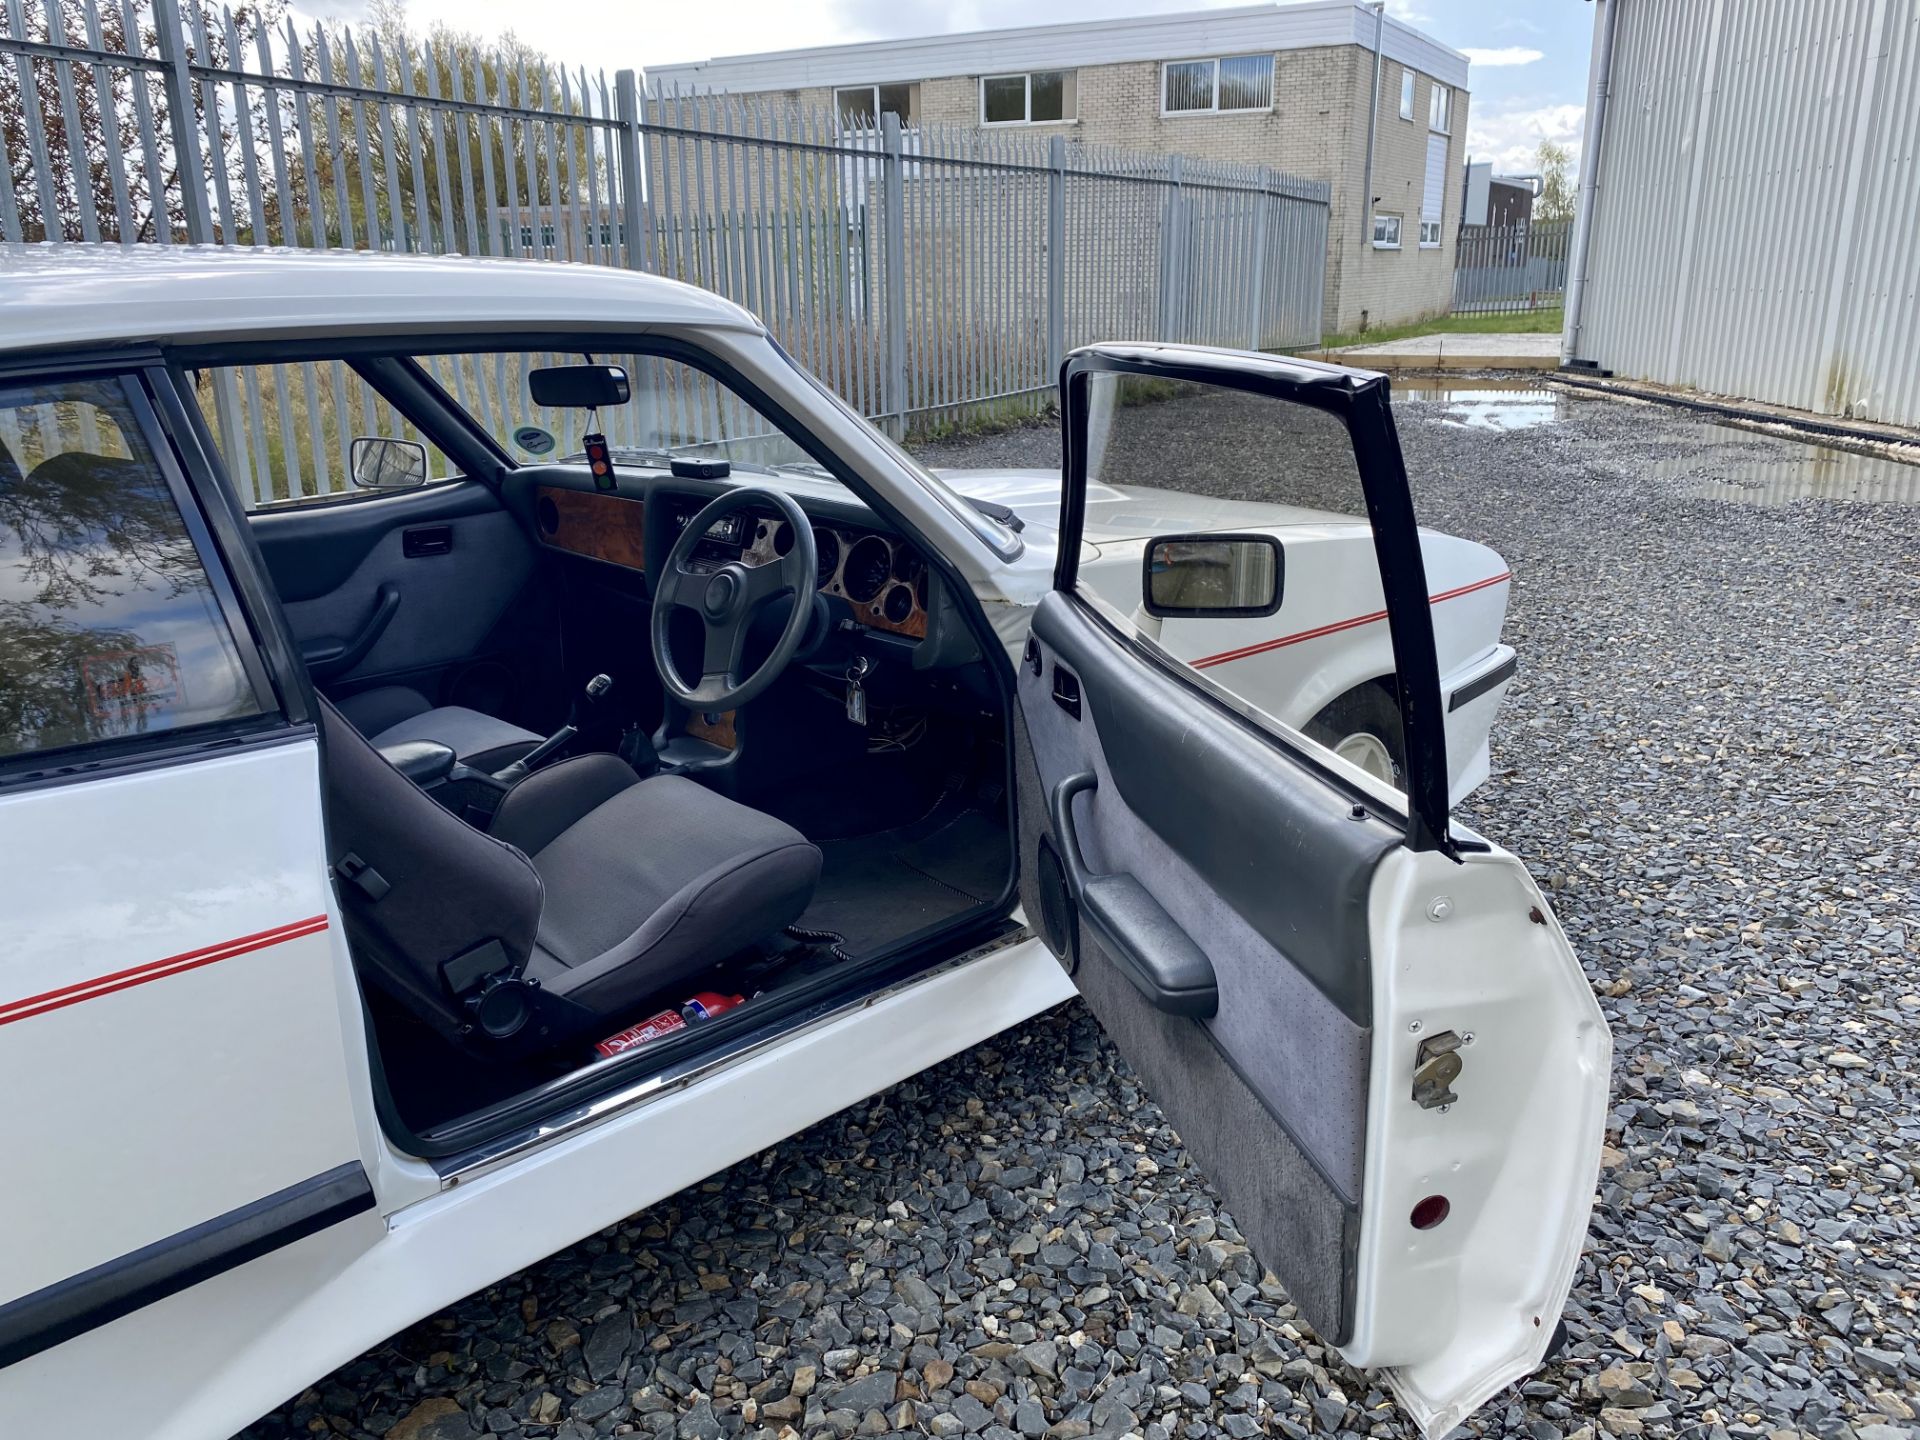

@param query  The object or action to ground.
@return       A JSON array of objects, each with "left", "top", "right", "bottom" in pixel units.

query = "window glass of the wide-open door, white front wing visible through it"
[{"left": 1077, "top": 372, "right": 1402, "bottom": 785}]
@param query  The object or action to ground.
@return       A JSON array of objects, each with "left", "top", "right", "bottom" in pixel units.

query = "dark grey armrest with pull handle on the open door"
[{"left": 1046, "top": 772, "right": 1219, "bottom": 1020}]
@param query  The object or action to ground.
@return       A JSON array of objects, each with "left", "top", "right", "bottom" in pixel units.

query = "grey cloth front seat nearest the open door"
[{"left": 321, "top": 701, "right": 820, "bottom": 1050}]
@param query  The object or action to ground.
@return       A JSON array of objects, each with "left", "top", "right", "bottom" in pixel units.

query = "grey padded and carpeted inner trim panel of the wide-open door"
[{"left": 1016, "top": 593, "right": 1398, "bottom": 1342}]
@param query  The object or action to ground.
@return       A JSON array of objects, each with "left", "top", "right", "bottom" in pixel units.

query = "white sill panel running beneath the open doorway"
[{"left": 0, "top": 939, "right": 1073, "bottom": 1440}]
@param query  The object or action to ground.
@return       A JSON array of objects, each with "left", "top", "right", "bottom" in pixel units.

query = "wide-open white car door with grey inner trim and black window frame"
[{"left": 1016, "top": 346, "right": 1611, "bottom": 1436}]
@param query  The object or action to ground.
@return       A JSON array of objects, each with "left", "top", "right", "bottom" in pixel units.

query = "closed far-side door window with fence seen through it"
[{"left": 190, "top": 361, "right": 459, "bottom": 511}]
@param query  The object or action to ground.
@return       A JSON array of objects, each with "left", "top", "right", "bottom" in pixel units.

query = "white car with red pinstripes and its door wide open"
[{"left": 0, "top": 246, "right": 1611, "bottom": 1438}]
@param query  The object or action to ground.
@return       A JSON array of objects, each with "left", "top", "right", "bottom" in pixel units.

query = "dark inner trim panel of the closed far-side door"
[{"left": 253, "top": 482, "right": 536, "bottom": 708}]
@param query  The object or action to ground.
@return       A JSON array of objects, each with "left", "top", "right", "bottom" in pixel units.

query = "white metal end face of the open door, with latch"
[{"left": 1342, "top": 847, "right": 1613, "bottom": 1436}]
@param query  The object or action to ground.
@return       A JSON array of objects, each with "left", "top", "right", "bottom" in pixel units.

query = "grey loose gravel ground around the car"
[{"left": 246, "top": 384, "right": 1920, "bottom": 1440}]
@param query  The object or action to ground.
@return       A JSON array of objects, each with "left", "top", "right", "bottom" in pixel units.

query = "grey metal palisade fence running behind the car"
[{"left": 0, "top": 0, "right": 1329, "bottom": 501}]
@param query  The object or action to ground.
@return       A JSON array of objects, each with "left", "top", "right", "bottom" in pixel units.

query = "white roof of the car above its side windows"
[{"left": 0, "top": 244, "right": 762, "bottom": 353}]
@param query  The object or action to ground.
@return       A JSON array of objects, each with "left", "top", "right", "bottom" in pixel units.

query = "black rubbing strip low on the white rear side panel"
[{"left": 0, "top": 1160, "right": 372, "bottom": 1369}]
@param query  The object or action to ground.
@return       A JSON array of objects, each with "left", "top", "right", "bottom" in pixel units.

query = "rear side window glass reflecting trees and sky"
[{"left": 0, "top": 380, "right": 259, "bottom": 758}]
